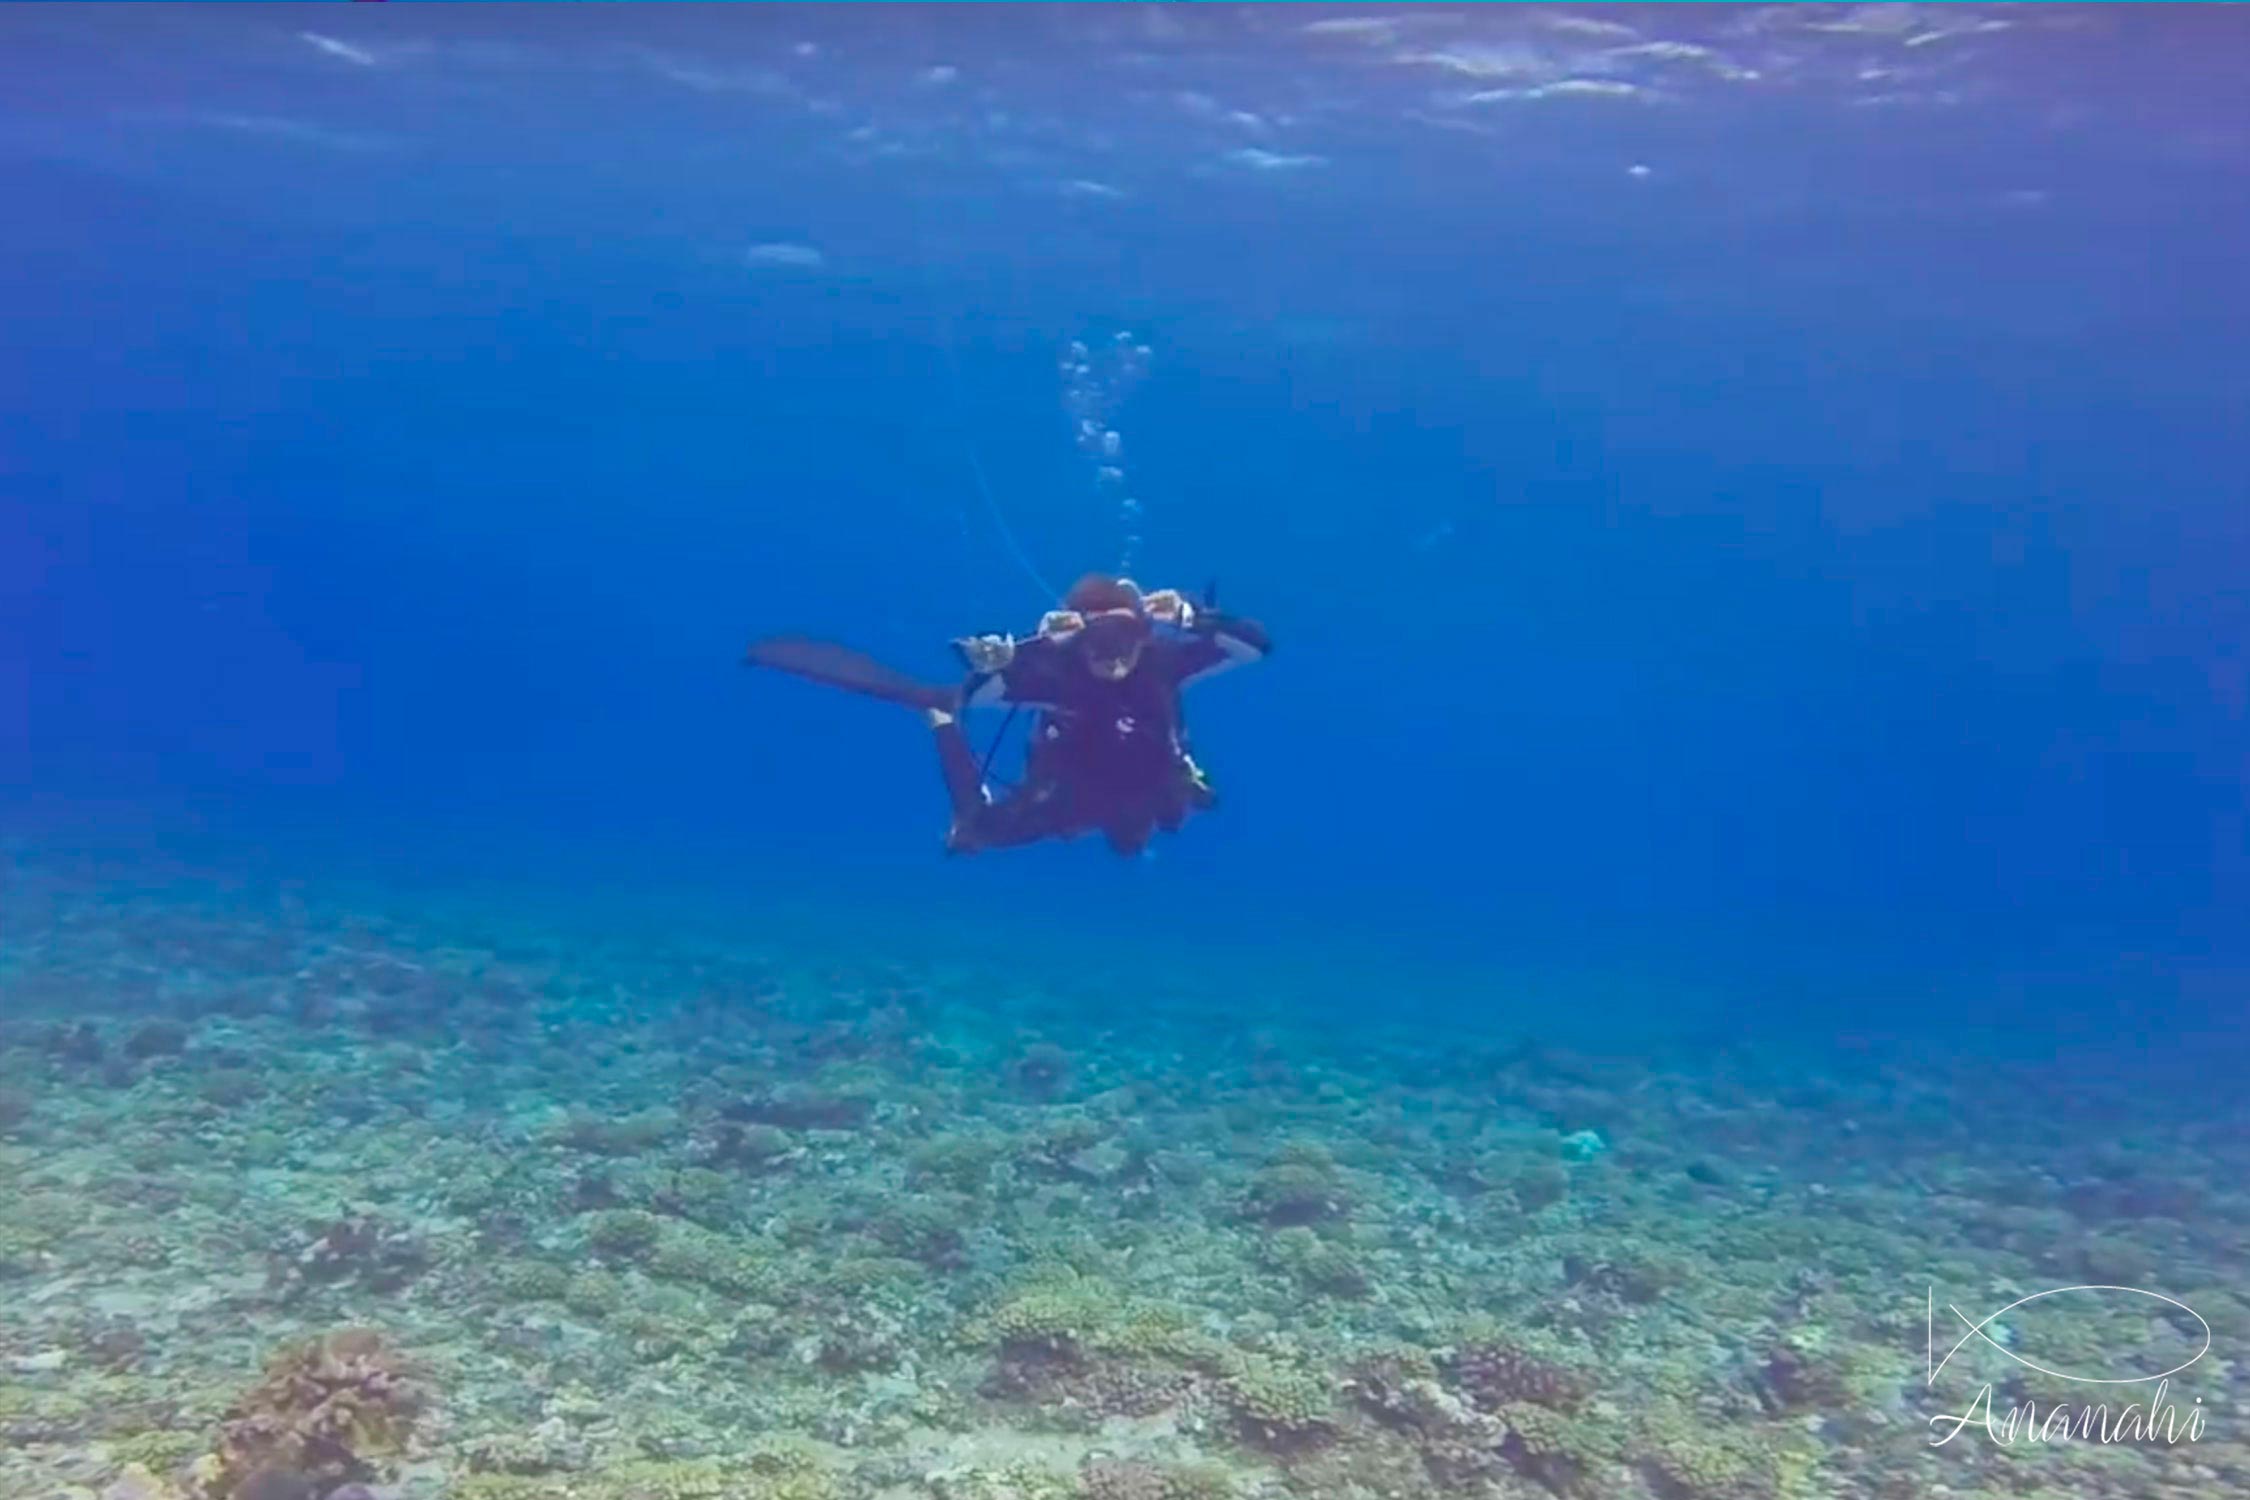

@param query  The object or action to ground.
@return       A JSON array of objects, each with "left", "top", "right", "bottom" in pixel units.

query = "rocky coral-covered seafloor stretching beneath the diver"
[{"left": 0, "top": 872, "right": 2250, "bottom": 1500}]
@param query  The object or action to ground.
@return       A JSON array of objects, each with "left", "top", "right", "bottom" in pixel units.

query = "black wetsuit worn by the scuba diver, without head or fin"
[{"left": 938, "top": 614, "right": 1269, "bottom": 855}]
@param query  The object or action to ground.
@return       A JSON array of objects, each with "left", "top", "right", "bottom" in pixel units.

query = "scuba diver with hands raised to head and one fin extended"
[{"left": 747, "top": 573, "right": 1271, "bottom": 855}]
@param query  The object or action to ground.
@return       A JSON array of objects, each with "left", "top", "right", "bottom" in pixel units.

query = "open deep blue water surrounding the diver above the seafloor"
[{"left": 0, "top": 7, "right": 2250, "bottom": 1046}]
